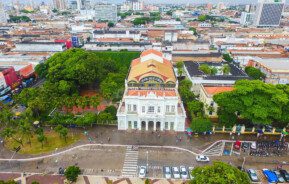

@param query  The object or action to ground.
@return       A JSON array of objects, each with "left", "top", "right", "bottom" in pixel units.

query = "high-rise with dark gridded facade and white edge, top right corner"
[{"left": 254, "top": 0, "right": 285, "bottom": 27}]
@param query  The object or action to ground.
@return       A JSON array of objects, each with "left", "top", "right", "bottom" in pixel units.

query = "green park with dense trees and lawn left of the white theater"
[{"left": 0, "top": 49, "right": 140, "bottom": 154}]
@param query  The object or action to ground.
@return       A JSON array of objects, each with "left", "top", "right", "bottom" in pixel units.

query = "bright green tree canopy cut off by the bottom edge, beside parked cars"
[{"left": 190, "top": 162, "right": 251, "bottom": 184}]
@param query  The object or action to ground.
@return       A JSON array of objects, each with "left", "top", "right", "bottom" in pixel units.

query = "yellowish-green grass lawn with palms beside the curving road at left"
[{"left": 5, "top": 131, "right": 84, "bottom": 155}]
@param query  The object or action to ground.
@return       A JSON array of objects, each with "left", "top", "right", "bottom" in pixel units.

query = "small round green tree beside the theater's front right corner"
[{"left": 191, "top": 117, "right": 212, "bottom": 133}]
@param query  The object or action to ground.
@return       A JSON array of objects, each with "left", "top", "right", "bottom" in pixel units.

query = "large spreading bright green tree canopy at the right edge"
[{"left": 213, "top": 80, "right": 289, "bottom": 124}]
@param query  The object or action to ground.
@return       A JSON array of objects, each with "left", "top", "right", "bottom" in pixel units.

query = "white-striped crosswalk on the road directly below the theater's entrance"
[{"left": 122, "top": 146, "right": 138, "bottom": 177}]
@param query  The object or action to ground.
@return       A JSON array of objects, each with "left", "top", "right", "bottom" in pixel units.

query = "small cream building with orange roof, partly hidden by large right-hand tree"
[{"left": 199, "top": 85, "right": 234, "bottom": 118}]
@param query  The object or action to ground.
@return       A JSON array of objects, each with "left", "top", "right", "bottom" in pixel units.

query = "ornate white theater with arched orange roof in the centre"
[{"left": 117, "top": 49, "right": 186, "bottom": 131}]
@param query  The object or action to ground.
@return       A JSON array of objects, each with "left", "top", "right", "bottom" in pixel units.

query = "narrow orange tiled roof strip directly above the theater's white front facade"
[{"left": 127, "top": 90, "right": 177, "bottom": 97}]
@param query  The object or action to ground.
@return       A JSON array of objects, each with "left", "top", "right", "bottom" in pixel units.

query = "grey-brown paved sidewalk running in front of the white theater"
[{"left": 0, "top": 126, "right": 279, "bottom": 158}]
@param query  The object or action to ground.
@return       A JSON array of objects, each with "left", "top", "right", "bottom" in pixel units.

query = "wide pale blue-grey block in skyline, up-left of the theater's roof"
[{"left": 94, "top": 4, "right": 117, "bottom": 22}]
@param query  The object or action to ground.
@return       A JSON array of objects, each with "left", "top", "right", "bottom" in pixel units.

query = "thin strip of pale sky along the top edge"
[{"left": 0, "top": 0, "right": 257, "bottom": 4}]
